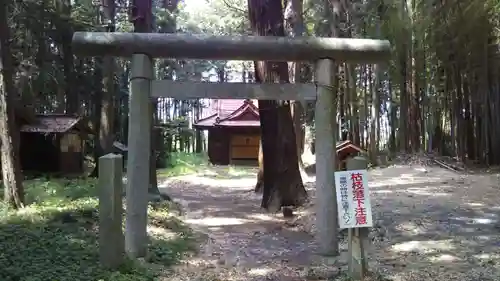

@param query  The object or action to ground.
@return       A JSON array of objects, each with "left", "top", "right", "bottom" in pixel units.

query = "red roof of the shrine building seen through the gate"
[{"left": 194, "top": 99, "right": 260, "bottom": 128}]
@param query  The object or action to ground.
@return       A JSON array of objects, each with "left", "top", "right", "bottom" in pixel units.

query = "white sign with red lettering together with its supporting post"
[{"left": 335, "top": 156, "right": 373, "bottom": 280}]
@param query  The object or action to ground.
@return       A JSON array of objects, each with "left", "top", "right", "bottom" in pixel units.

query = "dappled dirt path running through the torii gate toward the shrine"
[{"left": 162, "top": 168, "right": 330, "bottom": 280}]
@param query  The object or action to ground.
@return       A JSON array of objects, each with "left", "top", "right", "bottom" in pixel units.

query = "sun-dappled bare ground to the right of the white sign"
[{"left": 371, "top": 166, "right": 500, "bottom": 281}]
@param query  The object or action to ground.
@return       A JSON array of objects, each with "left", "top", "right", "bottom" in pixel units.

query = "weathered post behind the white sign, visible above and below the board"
[{"left": 347, "top": 156, "right": 370, "bottom": 280}]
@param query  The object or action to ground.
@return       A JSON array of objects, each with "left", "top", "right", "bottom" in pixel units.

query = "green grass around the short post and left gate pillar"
[{"left": 0, "top": 176, "right": 195, "bottom": 281}]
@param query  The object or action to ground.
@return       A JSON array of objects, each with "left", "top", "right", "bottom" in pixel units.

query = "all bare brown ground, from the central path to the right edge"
[{"left": 160, "top": 161, "right": 500, "bottom": 281}]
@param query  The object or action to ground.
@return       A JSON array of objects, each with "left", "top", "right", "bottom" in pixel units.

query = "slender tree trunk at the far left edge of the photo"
[{"left": 0, "top": 1, "right": 24, "bottom": 209}]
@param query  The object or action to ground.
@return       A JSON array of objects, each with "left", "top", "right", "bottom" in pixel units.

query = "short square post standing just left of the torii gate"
[{"left": 97, "top": 153, "right": 124, "bottom": 269}]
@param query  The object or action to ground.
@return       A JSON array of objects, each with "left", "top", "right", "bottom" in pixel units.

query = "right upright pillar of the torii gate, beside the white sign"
[{"left": 315, "top": 59, "right": 339, "bottom": 255}]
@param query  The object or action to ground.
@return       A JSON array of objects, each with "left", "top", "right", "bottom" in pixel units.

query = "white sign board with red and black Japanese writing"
[{"left": 335, "top": 170, "right": 373, "bottom": 228}]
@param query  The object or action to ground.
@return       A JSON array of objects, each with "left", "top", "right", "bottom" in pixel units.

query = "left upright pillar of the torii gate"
[{"left": 125, "top": 54, "right": 153, "bottom": 258}]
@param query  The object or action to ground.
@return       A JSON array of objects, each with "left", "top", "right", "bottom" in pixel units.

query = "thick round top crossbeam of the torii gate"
[{"left": 73, "top": 32, "right": 390, "bottom": 63}]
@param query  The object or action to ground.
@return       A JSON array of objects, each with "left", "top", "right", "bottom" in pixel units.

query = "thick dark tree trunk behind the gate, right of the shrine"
[{"left": 248, "top": 0, "right": 307, "bottom": 212}]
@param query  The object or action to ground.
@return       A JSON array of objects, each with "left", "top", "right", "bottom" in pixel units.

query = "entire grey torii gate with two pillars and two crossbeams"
[{"left": 73, "top": 32, "right": 390, "bottom": 257}]
